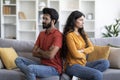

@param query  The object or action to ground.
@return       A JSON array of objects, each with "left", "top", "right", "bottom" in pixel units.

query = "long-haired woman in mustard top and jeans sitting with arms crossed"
[{"left": 63, "top": 11, "right": 109, "bottom": 80}]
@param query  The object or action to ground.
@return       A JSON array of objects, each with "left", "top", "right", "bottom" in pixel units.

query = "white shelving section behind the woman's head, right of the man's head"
[{"left": 59, "top": 0, "right": 95, "bottom": 37}]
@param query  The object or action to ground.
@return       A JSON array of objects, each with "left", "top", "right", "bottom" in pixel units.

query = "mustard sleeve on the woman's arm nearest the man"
[{"left": 66, "top": 34, "right": 85, "bottom": 58}]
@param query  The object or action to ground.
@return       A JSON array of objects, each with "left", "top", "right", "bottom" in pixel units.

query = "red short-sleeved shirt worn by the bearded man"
[{"left": 35, "top": 29, "right": 62, "bottom": 73}]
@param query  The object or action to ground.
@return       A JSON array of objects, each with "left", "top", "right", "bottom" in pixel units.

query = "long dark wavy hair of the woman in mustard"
[{"left": 62, "top": 11, "right": 88, "bottom": 58}]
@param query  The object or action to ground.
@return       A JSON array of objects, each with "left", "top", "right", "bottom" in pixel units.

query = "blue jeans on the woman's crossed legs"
[{"left": 66, "top": 60, "right": 109, "bottom": 80}]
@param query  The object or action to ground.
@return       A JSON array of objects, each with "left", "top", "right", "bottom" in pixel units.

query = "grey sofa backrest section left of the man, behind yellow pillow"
[{"left": 0, "top": 38, "right": 40, "bottom": 62}]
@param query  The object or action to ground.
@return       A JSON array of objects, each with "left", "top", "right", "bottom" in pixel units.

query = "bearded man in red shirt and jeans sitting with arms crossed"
[{"left": 15, "top": 8, "right": 62, "bottom": 80}]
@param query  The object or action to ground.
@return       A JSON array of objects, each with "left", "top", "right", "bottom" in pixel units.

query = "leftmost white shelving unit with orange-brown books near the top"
[{"left": 1, "top": 0, "right": 17, "bottom": 39}]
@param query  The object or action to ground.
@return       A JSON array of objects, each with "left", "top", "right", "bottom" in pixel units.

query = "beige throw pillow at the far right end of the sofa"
[{"left": 108, "top": 47, "right": 120, "bottom": 68}]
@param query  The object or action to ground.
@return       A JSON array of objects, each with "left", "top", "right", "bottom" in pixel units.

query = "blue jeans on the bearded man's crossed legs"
[{"left": 15, "top": 57, "right": 59, "bottom": 80}]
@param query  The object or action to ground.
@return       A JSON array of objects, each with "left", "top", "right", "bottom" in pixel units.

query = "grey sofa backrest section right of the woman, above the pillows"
[{"left": 91, "top": 37, "right": 120, "bottom": 46}]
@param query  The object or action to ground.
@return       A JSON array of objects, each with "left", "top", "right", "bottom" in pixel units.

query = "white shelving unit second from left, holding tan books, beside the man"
[{"left": 17, "top": 0, "right": 36, "bottom": 41}]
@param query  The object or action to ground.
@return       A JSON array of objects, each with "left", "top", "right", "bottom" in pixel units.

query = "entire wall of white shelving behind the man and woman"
[{"left": 1, "top": 0, "right": 95, "bottom": 41}]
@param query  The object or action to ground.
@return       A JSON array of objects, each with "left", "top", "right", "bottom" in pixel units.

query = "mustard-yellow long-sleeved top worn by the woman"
[{"left": 65, "top": 32, "right": 94, "bottom": 66}]
